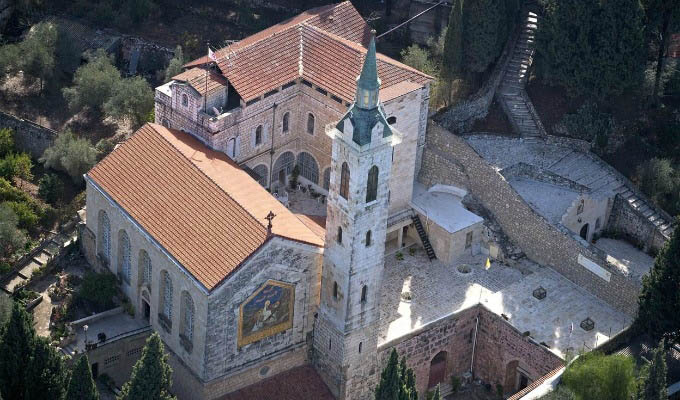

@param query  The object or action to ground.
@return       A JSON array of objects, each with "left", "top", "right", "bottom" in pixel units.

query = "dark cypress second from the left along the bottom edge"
[{"left": 25, "top": 338, "right": 68, "bottom": 400}]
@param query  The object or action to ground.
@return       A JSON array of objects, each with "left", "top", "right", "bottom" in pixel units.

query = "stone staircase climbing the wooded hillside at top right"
[{"left": 498, "top": 5, "right": 544, "bottom": 137}]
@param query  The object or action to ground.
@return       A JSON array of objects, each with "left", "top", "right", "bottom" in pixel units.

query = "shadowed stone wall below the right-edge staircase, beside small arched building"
[{"left": 607, "top": 196, "right": 666, "bottom": 251}]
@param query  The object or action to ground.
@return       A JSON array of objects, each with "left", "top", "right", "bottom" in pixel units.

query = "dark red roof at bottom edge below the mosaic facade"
[{"left": 220, "top": 366, "right": 335, "bottom": 400}]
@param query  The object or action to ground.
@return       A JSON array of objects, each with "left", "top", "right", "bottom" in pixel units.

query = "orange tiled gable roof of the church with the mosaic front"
[{"left": 87, "top": 124, "right": 324, "bottom": 291}]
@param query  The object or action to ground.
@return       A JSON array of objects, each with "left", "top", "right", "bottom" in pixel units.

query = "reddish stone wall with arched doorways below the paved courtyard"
[{"left": 378, "top": 305, "right": 562, "bottom": 398}]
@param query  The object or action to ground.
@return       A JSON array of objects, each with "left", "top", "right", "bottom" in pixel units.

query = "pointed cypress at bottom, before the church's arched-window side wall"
[{"left": 117, "top": 333, "right": 175, "bottom": 400}]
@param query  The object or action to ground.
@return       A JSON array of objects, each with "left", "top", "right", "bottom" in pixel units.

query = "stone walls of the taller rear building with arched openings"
[{"left": 155, "top": 79, "right": 429, "bottom": 214}]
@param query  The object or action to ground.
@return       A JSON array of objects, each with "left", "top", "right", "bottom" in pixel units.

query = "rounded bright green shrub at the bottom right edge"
[{"left": 562, "top": 352, "right": 635, "bottom": 400}]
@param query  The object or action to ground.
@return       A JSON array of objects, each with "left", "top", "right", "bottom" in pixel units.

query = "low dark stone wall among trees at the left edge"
[{"left": 0, "top": 111, "right": 57, "bottom": 158}]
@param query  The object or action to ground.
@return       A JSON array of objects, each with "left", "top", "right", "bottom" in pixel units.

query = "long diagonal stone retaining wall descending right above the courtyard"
[{"left": 419, "top": 124, "right": 638, "bottom": 315}]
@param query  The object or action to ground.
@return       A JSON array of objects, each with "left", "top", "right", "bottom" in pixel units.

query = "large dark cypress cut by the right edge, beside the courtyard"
[{"left": 635, "top": 221, "right": 680, "bottom": 344}]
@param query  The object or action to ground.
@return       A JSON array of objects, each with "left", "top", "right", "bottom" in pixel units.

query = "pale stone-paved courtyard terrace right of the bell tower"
[{"left": 378, "top": 249, "right": 632, "bottom": 356}]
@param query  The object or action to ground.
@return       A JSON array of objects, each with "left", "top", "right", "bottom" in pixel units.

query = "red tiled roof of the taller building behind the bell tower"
[{"left": 185, "top": 1, "right": 432, "bottom": 102}]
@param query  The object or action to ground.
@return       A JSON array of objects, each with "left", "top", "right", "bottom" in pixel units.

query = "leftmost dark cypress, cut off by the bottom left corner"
[{"left": 0, "top": 303, "right": 36, "bottom": 400}]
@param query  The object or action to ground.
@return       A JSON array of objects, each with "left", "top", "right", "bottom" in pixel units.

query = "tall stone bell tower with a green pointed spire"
[{"left": 314, "top": 38, "right": 396, "bottom": 399}]
